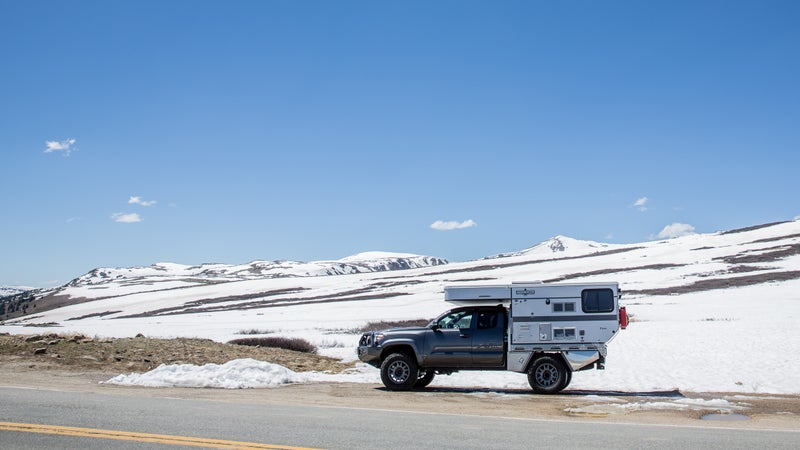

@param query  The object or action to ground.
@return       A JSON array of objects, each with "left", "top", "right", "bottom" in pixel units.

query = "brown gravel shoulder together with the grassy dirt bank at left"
[{"left": 0, "top": 335, "right": 800, "bottom": 432}]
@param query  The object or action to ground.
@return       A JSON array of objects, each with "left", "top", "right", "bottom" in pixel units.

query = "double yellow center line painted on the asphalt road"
[{"left": 0, "top": 422, "right": 318, "bottom": 450}]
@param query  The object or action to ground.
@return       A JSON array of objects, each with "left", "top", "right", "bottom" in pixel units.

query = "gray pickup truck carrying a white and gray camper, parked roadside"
[{"left": 358, "top": 283, "right": 627, "bottom": 394}]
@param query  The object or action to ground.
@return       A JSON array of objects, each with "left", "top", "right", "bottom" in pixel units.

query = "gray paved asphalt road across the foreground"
[{"left": 0, "top": 387, "right": 800, "bottom": 450}]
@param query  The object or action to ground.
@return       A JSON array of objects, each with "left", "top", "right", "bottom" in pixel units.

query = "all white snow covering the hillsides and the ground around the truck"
[{"left": 0, "top": 221, "right": 800, "bottom": 394}]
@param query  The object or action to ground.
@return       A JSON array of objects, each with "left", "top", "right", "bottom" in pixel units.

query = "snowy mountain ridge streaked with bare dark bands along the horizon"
[{"left": 0, "top": 220, "right": 800, "bottom": 326}]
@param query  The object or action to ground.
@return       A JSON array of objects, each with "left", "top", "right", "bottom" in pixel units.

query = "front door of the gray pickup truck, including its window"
[{"left": 423, "top": 309, "right": 475, "bottom": 368}]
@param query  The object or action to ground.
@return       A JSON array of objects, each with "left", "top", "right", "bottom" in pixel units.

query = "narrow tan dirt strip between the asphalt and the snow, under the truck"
[{"left": 0, "top": 360, "right": 800, "bottom": 431}]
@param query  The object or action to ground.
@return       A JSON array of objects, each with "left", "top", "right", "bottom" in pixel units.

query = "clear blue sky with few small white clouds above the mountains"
[{"left": 0, "top": 0, "right": 800, "bottom": 286}]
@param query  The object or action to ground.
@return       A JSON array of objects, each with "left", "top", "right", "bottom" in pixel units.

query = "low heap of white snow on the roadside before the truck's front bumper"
[{"left": 105, "top": 358, "right": 304, "bottom": 389}]
